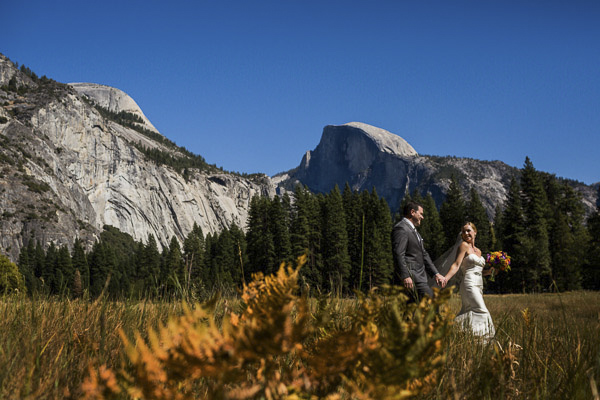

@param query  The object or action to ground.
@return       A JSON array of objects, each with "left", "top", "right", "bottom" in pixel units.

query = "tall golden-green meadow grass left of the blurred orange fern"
[{"left": 0, "top": 296, "right": 192, "bottom": 399}]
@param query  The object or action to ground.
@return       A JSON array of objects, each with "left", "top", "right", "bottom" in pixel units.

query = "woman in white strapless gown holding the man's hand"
[{"left": 435, "top": 222, "right": 495, "bottom": 341}]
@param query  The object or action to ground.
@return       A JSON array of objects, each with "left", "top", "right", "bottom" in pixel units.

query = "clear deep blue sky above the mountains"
[{"left": 0, "top": 0, "right": 600, "bottom": 184}]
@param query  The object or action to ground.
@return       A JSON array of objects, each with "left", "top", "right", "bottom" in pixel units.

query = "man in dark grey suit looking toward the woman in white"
[{"left": 392, "top": 201, "right": 446, "bottom": 301}]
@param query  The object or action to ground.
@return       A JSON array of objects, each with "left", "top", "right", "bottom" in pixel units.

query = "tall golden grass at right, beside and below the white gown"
[{"left": 432, "top": 292, "right": 600, "bottom": 399}]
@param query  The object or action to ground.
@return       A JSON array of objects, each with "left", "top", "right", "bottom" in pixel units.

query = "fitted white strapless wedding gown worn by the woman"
[{"left": 455, "top": 254, "right": 496, "bottom": 341}]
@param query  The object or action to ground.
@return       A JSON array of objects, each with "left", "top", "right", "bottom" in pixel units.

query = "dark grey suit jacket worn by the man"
[{"left": 392, "top": 218, "right": 438, "bottom": 284}]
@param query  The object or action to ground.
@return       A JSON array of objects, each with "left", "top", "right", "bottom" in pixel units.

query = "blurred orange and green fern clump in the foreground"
[{"left": 83, "top": 258, "right": 451, "bottom": 399}]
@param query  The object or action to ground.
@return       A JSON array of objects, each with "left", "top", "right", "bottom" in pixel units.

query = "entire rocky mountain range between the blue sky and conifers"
[{"left": 0, "top": 50, "right": 597, "bottom": 260}]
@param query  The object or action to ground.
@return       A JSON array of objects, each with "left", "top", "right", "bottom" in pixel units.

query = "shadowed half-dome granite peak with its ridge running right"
[{"left": 274, "top": 122, "right": 597, "bottom": 218}]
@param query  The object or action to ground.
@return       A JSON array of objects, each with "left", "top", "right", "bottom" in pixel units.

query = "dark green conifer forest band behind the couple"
[{"left": 8, "top": 159, "right": 600, "bottom": 298}]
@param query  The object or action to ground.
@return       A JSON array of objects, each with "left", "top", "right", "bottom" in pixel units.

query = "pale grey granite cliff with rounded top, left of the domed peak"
[{"left": 0, "top": 55, "right": 275, "bottom": 260}]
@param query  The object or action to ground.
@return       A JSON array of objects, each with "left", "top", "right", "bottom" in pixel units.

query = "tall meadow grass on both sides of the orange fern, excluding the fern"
[{"left": 0, "top": 292, "right": 600, "bottom": 399}]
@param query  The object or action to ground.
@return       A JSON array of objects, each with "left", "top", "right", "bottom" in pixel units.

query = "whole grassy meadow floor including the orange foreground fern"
[{"left": 0, "top": 270, "right": 600, "bottom": 399}]
